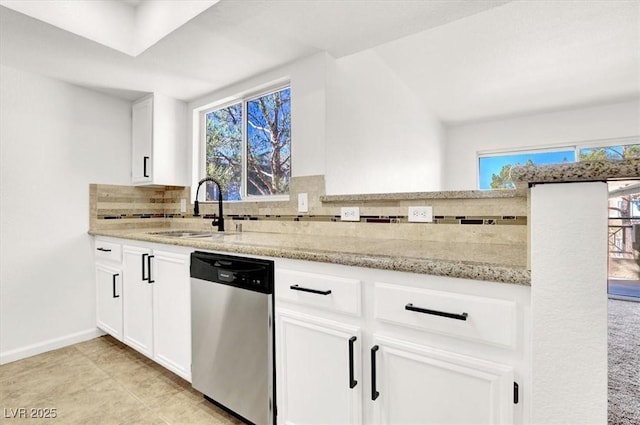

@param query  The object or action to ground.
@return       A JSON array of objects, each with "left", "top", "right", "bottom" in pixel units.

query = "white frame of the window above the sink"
[{"left": 192, "top": 81, "right": 293, "bottom": 203}]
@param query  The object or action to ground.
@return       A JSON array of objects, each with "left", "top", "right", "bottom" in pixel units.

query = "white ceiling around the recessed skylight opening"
[{"left": 0, "top": 0, "right": 640, "bottom": 122}]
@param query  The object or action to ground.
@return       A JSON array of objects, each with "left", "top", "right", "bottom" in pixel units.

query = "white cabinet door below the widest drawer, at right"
[{"left": 367, "top": 335, "right": 514, "bottom": 425}]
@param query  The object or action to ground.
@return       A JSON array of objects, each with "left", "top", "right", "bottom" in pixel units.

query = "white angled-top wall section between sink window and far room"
[{"left": 325, "top": 49, "right": 443, "bottom": 194}]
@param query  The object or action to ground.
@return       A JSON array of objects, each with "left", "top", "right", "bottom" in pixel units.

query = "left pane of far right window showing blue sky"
[{"left": 478, "top": 148, "right": 576, "bottom": 189}]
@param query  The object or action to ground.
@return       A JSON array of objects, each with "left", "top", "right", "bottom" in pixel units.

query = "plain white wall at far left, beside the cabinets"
[{"left": 0, "top": 66, "right": 131, "bottom": 363}]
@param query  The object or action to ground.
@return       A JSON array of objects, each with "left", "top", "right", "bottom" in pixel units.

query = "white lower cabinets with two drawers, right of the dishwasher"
[{"left": 276, "top": 260, "right": 529, "bottom": 425}]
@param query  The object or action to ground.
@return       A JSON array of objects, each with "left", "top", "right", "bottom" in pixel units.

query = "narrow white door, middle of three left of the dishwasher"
[{"left": 122, "top": 245, "right": 154, "bottom": 357}]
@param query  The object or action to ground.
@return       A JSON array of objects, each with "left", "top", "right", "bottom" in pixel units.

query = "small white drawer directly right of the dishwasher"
[{"left": 276, "top": 270, "right": 360, "bottom": 316}]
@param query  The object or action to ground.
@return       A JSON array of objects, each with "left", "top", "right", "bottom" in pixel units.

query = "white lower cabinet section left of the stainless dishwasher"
[{"left": 96, "top": 239, "right": 191, "bottom": 381}]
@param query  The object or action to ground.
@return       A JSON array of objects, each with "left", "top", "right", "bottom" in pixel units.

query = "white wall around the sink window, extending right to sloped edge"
[{"left": 189, "top": 49, "right": 443, "bottom": 194}]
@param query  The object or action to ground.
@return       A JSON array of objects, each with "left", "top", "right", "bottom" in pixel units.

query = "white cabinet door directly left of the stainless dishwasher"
[{"left": 152, "top": 250, "right": 191, "bottom": 381}]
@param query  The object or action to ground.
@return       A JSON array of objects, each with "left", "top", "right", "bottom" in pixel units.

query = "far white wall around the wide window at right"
[{"left": 444, "top": 100, "right": 640, "bottom": 190}]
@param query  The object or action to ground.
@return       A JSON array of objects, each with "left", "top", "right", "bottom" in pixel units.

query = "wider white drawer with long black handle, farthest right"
[{"left": 375, "top": 282, "right": 516, "bottom": 348}]
